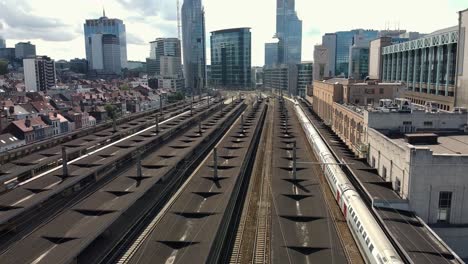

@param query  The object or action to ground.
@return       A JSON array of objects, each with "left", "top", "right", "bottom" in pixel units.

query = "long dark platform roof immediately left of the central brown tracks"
[{"left": 118, "top": 97, "right": 265, "bottom": 263}]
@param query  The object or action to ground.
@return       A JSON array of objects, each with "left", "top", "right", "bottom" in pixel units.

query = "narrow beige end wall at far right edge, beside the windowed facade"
[{"left": 455, "top": 9, "right": 468, "bottom": 107}]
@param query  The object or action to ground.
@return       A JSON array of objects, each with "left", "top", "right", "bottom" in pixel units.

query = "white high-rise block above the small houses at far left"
[{"left": 23, "top": 56, "right": 56, "bottom": 92}]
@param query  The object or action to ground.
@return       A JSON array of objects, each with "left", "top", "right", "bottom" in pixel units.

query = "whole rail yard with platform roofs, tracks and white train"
[{"left": 0, "top": 93, "right": 459, "bottom": 264}]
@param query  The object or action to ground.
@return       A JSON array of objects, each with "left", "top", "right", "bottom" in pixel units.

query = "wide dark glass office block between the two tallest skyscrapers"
[{"left": 211, "top": 28, "right": 252, "bottom": 89}]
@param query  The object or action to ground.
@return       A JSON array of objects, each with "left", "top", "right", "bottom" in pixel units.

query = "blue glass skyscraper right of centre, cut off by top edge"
[{"left": 276, "top": 0, "right": 302, "bottom": 64}]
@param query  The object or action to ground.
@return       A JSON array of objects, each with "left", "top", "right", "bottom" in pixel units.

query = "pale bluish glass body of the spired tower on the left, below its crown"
[{"left": 88, "top": 33, "right": 122, "bottom": 74}]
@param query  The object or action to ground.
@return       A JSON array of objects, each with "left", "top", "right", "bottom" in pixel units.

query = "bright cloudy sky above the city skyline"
[{"left": 0, "top": 0, "right": 468, "bottom": 66}]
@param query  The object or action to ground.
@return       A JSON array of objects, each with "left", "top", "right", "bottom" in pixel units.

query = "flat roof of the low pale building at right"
[{"left": 391, "top": 132, "right": 468, "bottom": 155}]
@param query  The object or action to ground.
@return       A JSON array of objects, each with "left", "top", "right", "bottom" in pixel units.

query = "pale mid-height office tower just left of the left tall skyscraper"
[{"left": 147, "top": 38, "right": 182, "bottom": 77}]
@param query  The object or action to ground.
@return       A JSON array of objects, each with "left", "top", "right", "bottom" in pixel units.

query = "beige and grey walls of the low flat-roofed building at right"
[{"left": 367, "top": 129, "right": 468, "bottom": 224}]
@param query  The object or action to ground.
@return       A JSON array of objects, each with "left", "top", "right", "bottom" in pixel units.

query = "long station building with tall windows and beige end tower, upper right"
[{"left": 369, "top": 9, "right": 468, "bottom": 111}]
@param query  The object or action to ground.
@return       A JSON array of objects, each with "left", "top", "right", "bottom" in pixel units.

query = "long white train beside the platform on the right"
[{"left": 294, "top": 98, "right": 403, "bottom": 264}]
